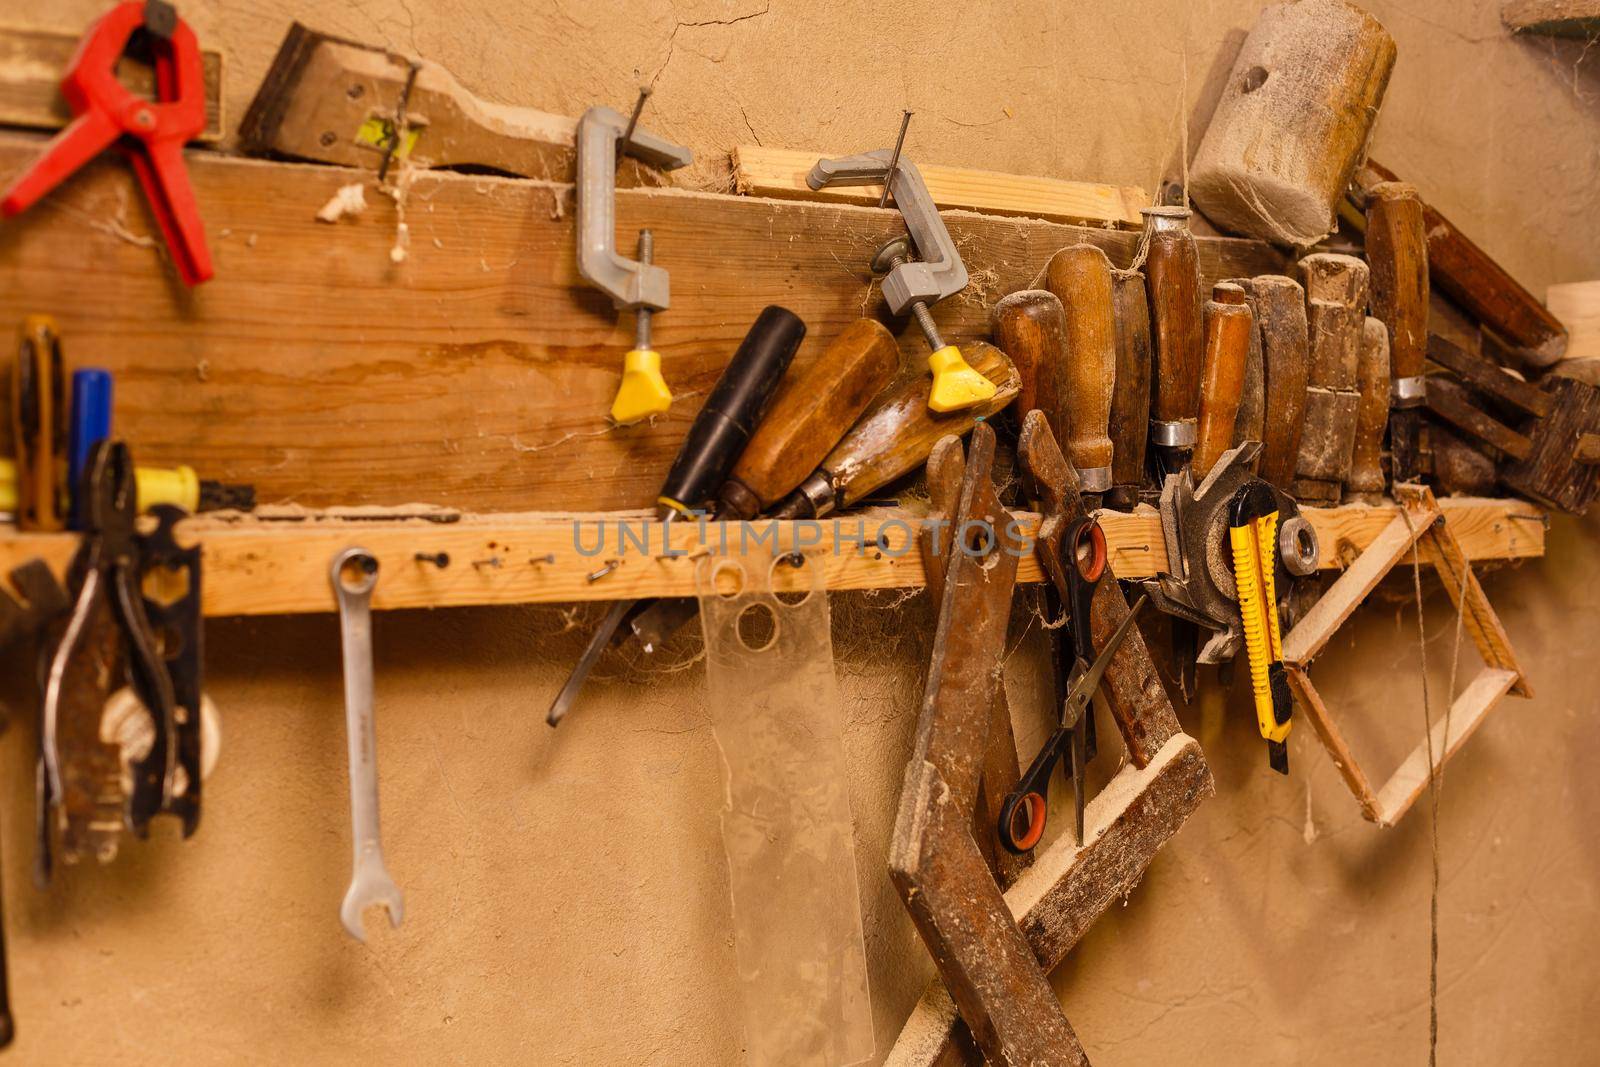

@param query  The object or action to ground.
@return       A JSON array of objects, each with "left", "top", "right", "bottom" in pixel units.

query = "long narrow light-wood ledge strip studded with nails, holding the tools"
[{"left": 0, "top": 499, "right": 1544, "bottom": 616}]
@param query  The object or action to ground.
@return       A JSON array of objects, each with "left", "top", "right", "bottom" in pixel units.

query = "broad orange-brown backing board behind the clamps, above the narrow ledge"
[{"left": 0, "top": 134, "right": 1283, "bottom": 512}]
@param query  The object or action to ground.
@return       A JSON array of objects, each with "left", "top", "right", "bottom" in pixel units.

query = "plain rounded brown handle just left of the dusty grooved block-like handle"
[{"left": 1243, "top": 274, "right": 1309, "bottom": 491}]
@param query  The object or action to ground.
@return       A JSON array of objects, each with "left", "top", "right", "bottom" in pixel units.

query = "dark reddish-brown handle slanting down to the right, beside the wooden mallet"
[{"left": 1354, "top": 160, "right": 1566, "bottom": 366}]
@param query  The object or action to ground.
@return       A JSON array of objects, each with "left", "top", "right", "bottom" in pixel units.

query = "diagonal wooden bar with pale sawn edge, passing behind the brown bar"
[{"left": 883, "top": 734, "right": 1214, "bottom": 1067}]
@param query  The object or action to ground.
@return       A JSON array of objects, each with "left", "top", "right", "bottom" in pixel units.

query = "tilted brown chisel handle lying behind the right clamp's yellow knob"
[{"left": 768, "top": 341, "right": 1021, "bottom": 518}]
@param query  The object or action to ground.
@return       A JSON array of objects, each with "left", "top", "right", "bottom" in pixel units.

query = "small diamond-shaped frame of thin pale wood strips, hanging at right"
[{"left": 1283, "top": 485, "right": 1533, "bottom": 827}]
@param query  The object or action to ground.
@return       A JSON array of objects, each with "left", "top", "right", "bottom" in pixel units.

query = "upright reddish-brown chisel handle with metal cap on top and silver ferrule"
[{"left": 1142, "top": 208, "right": 1203, "bottom": 464}]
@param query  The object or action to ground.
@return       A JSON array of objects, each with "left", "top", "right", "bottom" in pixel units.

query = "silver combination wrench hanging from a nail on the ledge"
[{"left": 330, "top": 549, "right": 405, "bottom": 942}]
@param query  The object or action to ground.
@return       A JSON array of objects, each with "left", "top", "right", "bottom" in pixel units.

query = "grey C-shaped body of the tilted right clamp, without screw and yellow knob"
[{"left": 805, "top": 149, "right": 966, "bottom": 315}]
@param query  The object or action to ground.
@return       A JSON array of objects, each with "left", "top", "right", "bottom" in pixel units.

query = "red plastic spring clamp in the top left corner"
[{"left": 0, "top": 0, "right": 211, "bottom": 285}]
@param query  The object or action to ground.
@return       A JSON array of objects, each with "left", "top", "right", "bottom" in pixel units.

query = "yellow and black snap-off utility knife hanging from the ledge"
[{"left": 1227, "top": 480, "right": 1294, "bottom": 774}]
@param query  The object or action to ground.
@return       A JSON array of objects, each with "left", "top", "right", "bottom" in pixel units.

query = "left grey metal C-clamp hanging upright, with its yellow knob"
[{"left": 576, "top": 107, "right": 694, "bottom": 426}]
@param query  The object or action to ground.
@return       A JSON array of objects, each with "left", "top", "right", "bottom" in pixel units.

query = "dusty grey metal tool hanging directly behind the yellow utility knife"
[{"left": 1144, "top": 442, "right": 1318, "bottom": 664}]
